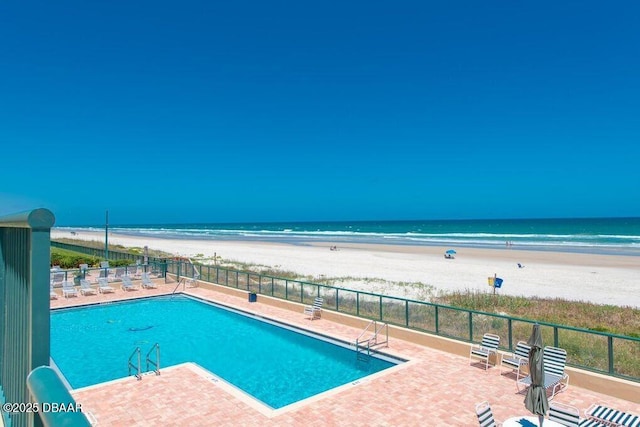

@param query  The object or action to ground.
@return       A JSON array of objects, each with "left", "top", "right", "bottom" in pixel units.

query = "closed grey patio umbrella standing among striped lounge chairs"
[{"left": 524, "top": 323, "right": 549, "bottom": 426}]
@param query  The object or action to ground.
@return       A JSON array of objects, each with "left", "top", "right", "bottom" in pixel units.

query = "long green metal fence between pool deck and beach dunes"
[{"left": 52, "top": 242, "right": 640, "bottom": 382}]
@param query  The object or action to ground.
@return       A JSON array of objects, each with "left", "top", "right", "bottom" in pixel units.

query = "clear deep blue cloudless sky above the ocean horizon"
[{"left": 0, "top": 0, "right": 640, "bottom": 225}]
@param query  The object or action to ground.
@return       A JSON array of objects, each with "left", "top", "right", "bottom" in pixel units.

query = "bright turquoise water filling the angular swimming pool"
[{"left": 51, "top": 297, "right": 396, "bottom": 409}]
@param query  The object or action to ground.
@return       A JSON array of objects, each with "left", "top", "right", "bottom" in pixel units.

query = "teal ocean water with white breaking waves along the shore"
[{"left": 57, "top": 218, "right": 640, "bottom": 256}]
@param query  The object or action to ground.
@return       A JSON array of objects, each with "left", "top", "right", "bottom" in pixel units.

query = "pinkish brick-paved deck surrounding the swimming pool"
[{"left": 51, "top": 280, "right": 640, "bottom": 427}]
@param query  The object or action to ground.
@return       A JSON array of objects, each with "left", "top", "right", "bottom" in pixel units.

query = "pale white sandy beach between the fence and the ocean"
[{"left": 51, "top": 229, "right": 640, "bottom": 308}]
